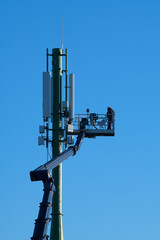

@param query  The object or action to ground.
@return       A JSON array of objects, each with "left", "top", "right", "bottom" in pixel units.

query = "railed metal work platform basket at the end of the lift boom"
[{"left": 67, "top": 113, "right": 115, "bottom": 138}]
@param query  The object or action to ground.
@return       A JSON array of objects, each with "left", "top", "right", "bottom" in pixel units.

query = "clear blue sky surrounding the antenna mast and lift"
[{"left": 0, "top": 0, "right": 160, "bottom": 240}]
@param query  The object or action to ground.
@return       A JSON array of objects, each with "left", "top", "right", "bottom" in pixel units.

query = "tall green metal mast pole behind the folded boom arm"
[{"left": 50, "top": 48, "right": 63, "bottom": 240}]
